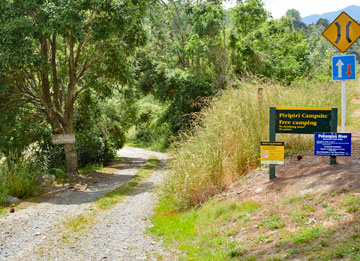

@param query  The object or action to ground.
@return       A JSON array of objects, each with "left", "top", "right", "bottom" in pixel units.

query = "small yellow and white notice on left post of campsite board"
[{"left": 261, "top": 141, "right": 285, "bottom": 164}]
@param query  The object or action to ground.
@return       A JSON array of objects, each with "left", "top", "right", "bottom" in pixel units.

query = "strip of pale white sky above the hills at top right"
[{"left": 263, "top": 0, "right": 360, "bottom": 19}]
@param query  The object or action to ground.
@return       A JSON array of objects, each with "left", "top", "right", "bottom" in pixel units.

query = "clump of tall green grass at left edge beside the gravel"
[{"left": 0, "top": 153, "right": 42, "bottom": 205}]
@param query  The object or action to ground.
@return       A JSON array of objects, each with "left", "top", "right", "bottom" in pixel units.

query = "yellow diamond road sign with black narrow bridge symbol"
[{"left": 322, "top": 12, "right": 360, "bottom": 53}]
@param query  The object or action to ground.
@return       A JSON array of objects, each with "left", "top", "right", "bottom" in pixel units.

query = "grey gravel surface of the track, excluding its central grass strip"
[{"left": 0, "top": 147, "right": 174, "bottom": 260}]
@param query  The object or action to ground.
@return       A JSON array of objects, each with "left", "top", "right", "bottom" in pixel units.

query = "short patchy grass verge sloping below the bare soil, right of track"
[{"left": 150, "top": 189, "right": 360, "bottom": 260}]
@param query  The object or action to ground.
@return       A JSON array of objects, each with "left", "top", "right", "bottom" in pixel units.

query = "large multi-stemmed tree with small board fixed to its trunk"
[{"left": 0, "top": 0, "right": 146, "bottom": 174}]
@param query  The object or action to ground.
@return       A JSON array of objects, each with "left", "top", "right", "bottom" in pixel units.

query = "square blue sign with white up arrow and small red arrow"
[{"left": 332, "top": 55, "right": 356, "bottom": 81}]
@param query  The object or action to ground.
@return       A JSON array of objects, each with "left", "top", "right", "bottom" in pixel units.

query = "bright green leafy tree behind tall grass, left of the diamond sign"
[{"left": 232, "top": 18, "right": 311, "bottom": 84}]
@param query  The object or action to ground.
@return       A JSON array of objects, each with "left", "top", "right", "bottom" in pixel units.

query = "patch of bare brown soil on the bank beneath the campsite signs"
[{"left": 223, "top": 132, "right": 360, "bottom": 205}]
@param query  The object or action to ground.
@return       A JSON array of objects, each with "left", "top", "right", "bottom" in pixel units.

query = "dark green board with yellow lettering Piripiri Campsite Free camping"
[{"left": 275, "top": 107, "right": 332, "bottom": 134}]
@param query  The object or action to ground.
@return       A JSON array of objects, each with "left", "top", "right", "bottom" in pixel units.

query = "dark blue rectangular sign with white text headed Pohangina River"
[{"left": 314, "top": 132, "right": 351, "bottom": 156}]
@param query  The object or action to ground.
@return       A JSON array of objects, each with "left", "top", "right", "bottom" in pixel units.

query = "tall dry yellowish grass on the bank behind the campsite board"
[{"left": 162, "top": 83, "right": 352, "bottom": 209}]
